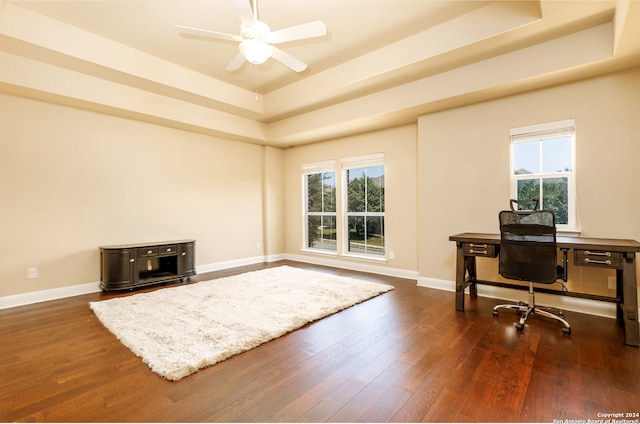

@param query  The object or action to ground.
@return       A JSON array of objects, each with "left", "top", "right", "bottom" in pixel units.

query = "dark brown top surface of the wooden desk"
[{"left": 449, "top": 233, "right": 640, "bottom": 252}]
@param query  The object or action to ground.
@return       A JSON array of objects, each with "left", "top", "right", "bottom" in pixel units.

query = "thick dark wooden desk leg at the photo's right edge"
[{"left": 618, "top": 252, "right": 640, "bottom": 346}]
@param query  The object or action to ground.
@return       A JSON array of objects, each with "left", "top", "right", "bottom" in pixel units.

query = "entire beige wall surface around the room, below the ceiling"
[{"left": 0, "top": 68, "right": 640, "bottom": 304}]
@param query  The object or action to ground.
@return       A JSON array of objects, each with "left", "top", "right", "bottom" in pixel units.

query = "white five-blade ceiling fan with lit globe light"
[{"left": 174, "top": 0, "right": 327, "bottom": 72}]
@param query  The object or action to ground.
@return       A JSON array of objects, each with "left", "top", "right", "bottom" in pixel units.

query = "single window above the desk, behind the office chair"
[{"left": 511, "top": 119, "right": 578, "bottom": 230}]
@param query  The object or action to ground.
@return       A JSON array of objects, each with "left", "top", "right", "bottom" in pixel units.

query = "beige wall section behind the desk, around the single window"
[{"left": 418, "top": 68, "right": 640, "bottom": 295}]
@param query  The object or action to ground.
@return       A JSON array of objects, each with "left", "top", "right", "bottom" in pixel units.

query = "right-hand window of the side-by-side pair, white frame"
[{"left": 342, "top": 154, "right": 385, "bottom": 257}]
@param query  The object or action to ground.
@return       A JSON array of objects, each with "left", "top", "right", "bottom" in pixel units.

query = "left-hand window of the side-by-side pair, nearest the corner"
[{"left": 303, "top": 162, "right": 337, "bottom": 252}]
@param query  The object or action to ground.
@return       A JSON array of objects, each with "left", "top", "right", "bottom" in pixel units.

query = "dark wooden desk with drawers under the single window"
[{"left": 449, "top": 233, "right": 640, "bottom": 346}]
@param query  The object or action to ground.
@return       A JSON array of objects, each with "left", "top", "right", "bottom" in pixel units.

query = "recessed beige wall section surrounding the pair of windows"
[{"left": 285, "top": 125, "right": 417, "bottom": 271}]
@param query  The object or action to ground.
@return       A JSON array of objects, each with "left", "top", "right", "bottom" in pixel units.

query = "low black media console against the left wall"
[{"left": 100, "top": 240, "right": 196, "bottom": 290}]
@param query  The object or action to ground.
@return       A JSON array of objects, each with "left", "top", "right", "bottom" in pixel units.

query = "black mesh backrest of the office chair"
[{"left": 499, "top": 207, "right": 558, "bottom": 284}]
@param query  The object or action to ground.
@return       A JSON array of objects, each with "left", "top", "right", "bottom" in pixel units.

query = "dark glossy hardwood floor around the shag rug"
[{"left": 0, "top": 262, "right": 640, "bottom": 422}]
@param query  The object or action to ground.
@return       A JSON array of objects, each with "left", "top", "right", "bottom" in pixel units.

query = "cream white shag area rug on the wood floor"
[{"left": 89, "top": 266, "right": 393, "bottom": 381}]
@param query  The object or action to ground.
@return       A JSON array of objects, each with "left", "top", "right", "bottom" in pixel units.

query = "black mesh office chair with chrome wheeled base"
[{"left": 493, "top": 199, "right": 571, "bottom": 334}]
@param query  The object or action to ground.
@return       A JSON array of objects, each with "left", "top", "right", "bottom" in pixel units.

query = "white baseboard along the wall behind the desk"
[{"left": 418, "top": 277, "right": 617, "bottom": 318}]
